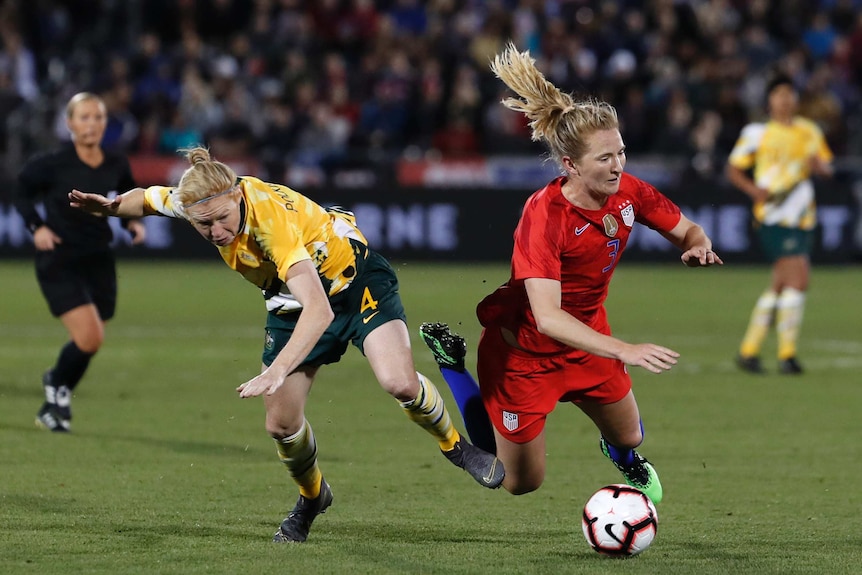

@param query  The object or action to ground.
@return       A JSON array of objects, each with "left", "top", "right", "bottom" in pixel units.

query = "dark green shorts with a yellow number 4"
[{"left": 262, "top": 250, "right": 407, "bottom": 367}]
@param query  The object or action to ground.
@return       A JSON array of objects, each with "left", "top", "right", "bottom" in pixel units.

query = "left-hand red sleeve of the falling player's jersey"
[{"left": 512, "top": 192, "right": 563, "bottom": 281}]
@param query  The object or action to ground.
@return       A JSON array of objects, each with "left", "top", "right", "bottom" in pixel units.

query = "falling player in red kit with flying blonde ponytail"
[{"left": 420, "top": 45, "right": 722, "bottom": 503}]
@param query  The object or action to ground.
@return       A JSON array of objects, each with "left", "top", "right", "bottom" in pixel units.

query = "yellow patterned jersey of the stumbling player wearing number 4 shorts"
[{"left": 144, "top": 176, "right": 367, "bottom": 313}]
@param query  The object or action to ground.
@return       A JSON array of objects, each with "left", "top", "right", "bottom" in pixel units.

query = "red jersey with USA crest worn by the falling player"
[{"left": 477, "top": 173, "right": 681, "bottom": 354}]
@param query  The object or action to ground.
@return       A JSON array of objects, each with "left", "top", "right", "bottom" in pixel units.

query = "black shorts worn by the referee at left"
[{"left": 36, "top": 248, "right": 117, "bottom": 321}]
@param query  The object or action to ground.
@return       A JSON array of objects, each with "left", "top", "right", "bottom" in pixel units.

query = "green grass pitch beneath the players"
[{"left": 0, "top": 261, "right": 862, "bottom": 575}]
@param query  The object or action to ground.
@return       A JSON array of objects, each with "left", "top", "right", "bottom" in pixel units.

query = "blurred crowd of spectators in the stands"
[{"left": 0, "top": 0, "right": 862, "bottom": 182}]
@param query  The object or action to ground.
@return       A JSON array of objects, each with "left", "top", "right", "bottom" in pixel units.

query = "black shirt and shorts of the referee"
[{"left": 15, "top": 143, "right": 136, "bottom": 321}]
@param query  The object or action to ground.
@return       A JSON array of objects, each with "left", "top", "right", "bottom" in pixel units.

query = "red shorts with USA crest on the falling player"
[{"left": 476, "top": 328, "right": 632, "bottom": 443}]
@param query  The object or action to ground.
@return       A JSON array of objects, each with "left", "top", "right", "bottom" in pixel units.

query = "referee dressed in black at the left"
[{"left": 15, "top": 92, "right": 146, "bottom": 432}]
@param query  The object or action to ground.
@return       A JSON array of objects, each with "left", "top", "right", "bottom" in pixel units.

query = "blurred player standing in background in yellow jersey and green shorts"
[{"left": 726, "top": 74, "right": 833, "bottom": 374}]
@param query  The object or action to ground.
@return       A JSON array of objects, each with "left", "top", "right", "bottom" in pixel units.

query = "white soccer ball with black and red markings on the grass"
[{"left": 582, "top": 484, "right": 658, "bottom": 557}]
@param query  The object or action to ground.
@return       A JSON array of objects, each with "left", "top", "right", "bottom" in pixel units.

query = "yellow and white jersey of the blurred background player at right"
[{"left": 729, "top": 116, "right": 832, "bottom": 230}]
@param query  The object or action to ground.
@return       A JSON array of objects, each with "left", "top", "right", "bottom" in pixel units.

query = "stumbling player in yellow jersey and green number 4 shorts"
[{"left": 69, "top": 147, "right": 504, "bottom": 542}]
